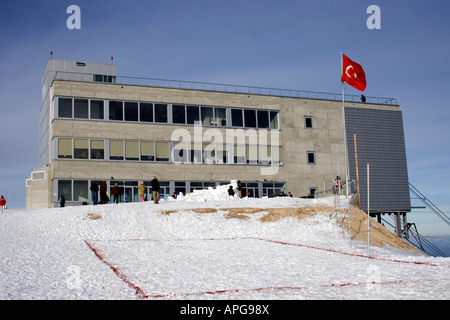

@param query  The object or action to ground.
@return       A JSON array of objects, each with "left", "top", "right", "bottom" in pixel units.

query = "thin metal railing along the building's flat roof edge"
[{"left": 53, "top": 71, "right": 398, "bottom": 105}]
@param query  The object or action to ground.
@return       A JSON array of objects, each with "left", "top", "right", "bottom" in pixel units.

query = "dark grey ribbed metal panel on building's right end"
[{"left": 345, "top": 108, "right": 411, "bottom": 212}]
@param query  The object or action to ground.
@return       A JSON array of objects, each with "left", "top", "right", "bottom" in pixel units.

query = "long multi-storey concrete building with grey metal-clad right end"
[{"left": 26, "top": 60, "right": 410, "bottom": 218}]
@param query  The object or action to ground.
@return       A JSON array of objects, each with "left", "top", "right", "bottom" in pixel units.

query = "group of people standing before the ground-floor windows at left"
[{"left": 89, "top": 176, "right": 160, "bottom": 205}]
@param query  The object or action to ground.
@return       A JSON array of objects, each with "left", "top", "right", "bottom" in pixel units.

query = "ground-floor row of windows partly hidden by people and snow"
[{"left": 55, "top": 180, "right": 286, "bottom": 204}]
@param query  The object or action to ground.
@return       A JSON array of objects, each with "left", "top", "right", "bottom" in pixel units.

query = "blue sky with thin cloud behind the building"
[{"left": 0, "top": 0, "right": 450, "bottom": 238}]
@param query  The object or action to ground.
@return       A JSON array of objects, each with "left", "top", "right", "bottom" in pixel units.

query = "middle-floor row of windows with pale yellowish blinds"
[{"left": 55, "top": 138, "right": 283, "bottom": 165}]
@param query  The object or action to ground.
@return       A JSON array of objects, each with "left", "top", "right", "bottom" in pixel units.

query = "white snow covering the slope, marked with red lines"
[{"left": 0, "top": 182, "right": 450, "bottom": 300}]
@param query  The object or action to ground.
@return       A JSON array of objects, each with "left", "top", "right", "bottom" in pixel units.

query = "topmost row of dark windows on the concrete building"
[{"left": 55, "top": 97, "right": 280, "bottom": 129}]
